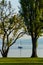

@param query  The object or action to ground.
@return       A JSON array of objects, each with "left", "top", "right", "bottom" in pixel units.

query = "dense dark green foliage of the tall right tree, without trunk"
[{"left": 20, "top": 0, "right": 43, "bottom": 38}]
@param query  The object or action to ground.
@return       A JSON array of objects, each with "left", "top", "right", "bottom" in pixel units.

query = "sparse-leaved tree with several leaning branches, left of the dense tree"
[{"left": 0, "top": 0, "right": 25, "bottom": 57}]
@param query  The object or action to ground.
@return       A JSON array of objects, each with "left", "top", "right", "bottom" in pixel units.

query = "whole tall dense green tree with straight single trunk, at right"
[{"left": 20, "top": 0, "right": 43, "bottom": 57}]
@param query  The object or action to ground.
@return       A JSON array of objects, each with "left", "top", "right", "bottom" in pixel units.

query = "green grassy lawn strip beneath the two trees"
[{"left": 0, "top": 58, "right": 43, "bottom": 65}]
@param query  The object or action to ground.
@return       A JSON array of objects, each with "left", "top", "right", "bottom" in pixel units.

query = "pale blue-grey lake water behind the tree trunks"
[{"left": 0, "top": 37, "right": 43, "bottom": 57}]
